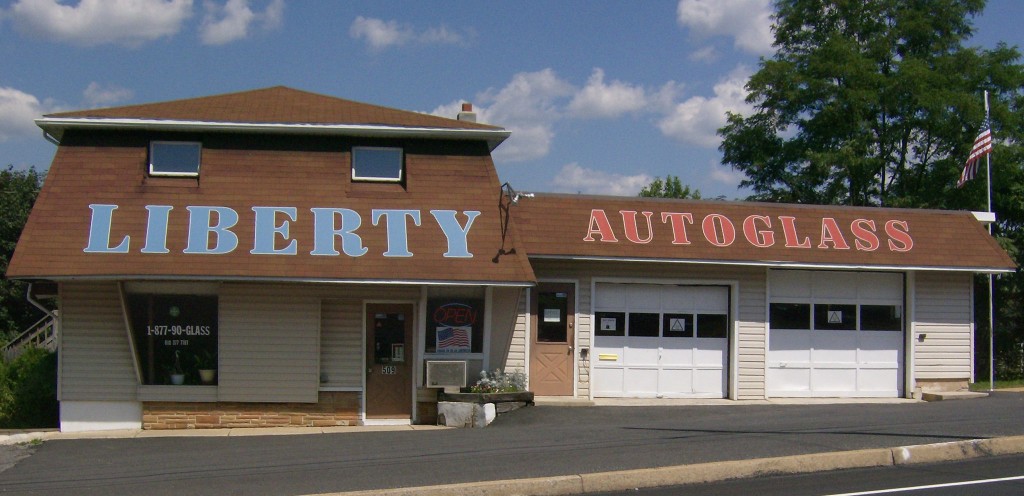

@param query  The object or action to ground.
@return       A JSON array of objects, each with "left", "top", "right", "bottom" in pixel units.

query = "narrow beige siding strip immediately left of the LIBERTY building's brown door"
[{"left": 319, "top": 299, "right": 365, "bottom": 388}]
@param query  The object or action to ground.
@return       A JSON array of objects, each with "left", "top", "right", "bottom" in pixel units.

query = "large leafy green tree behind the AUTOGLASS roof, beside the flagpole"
[{"left": 719, "top": 0, "right": 1024, "bottom": 377}]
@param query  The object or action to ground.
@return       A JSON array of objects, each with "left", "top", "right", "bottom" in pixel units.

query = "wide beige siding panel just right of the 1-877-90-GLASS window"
[{"left": 218, "top": 284, "right": 319, "bottom": 403}]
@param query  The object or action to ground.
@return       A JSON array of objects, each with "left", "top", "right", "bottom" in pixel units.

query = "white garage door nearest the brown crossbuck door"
[{"left": 592, "top": 283, "right": 731, "bottom": 398}]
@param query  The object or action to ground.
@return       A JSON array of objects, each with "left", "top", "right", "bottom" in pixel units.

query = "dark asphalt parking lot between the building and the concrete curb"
[{"left": 0, "top": 392, "right": 1024, "bottom": 495}]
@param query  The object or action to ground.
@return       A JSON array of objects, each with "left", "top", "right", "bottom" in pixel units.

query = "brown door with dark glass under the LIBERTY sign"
[{"left": 366, "top": 303, "right": 414, "bottom": 419}]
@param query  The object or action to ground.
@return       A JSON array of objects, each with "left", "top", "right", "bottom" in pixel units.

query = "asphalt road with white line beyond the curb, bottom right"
[{"left": 595, "top": 455, "right": 1024, "bottom": 496}]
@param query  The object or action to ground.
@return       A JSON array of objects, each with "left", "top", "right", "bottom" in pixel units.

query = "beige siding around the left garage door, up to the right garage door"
[{"left": 523, "top": 260, "right": 767, "bottom": 400}]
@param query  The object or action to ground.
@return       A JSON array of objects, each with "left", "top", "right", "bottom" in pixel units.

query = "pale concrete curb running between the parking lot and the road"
[{"left": 316, "top": 436, "right": 1024, "bottom": 496}]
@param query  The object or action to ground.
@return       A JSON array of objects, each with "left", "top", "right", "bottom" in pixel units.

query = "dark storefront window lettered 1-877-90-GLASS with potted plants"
[{"left": 127, "top": 294, "right": 217, "bottom": 385}]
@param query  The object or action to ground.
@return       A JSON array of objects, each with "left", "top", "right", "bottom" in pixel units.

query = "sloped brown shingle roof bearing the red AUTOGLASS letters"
[{"left": 514, "top": 194, "right": 1016, "bottom": 272}]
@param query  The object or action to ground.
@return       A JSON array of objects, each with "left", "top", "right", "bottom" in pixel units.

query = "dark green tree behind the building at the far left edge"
[{"left": 0, "top": 166, "right": 44, "bottom": 342}]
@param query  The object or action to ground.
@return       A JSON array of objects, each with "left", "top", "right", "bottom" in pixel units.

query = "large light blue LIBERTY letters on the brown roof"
[{"left": 83, "top": 204, "right": 480, "bottom": 258}]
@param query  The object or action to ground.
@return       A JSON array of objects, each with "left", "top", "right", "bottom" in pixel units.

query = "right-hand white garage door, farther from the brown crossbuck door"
[{"left": 766, "top": 271, "right": 904, "bottom": 398}]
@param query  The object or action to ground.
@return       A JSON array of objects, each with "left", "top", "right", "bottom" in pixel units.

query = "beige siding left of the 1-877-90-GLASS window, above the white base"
[{"left": 59, "top": 282, "right": 138, "bottom": 401}]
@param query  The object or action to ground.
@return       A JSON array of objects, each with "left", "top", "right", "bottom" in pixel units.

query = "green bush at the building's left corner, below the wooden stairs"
[{"left": 0, "top": 348, "right": 58, "bottom": 428}]
